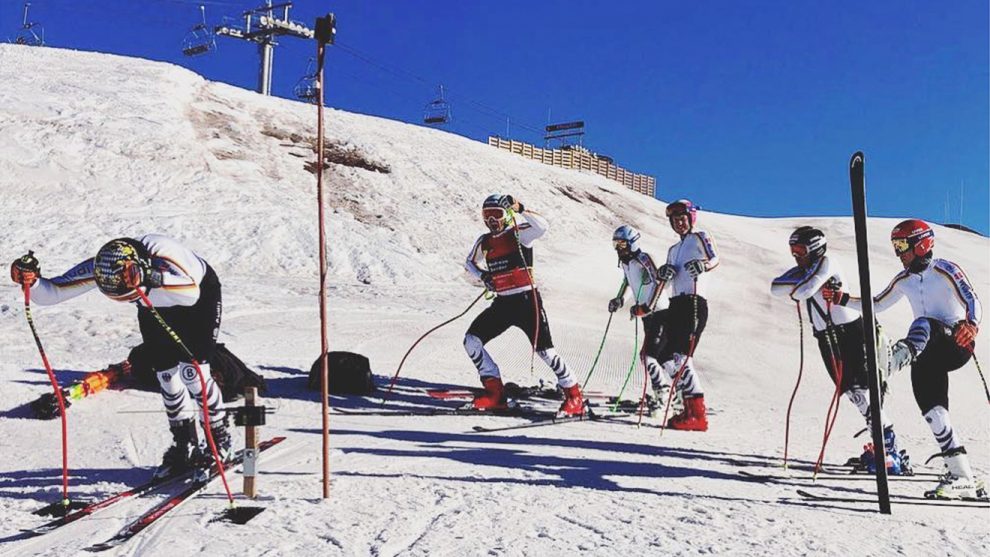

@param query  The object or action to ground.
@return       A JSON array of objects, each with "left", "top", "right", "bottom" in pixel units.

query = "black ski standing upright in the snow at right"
[{"left": 849, "top": 151, "right": 890, "bottom": 514}]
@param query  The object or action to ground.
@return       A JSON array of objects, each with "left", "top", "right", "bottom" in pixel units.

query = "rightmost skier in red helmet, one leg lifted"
[{"left": 823, "top": 219, "right": 987, "bottom": 499}]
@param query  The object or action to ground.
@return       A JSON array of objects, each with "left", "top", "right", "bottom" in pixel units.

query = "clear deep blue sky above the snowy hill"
[{"left": 0, "top": 0, "right": 990, "bottom": 234}]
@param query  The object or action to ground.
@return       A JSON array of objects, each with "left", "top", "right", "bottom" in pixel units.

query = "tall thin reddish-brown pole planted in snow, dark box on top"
[{"left": 316, "top": 14, "right": 335, "bottom": 499}]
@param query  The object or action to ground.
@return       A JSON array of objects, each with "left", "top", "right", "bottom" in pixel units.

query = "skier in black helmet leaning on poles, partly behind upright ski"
[{"left": 770, "top": 226, "right": 912, "bottom": 475}]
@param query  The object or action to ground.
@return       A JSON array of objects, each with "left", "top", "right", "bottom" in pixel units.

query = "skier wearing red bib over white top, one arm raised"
[{"left": 464, "top": 194, "right": 585, "bottom": 415}]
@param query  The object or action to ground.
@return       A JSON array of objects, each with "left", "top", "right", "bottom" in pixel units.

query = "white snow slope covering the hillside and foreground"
[{"left": 0, "top": 45, "right": 990, "bottom": 556}]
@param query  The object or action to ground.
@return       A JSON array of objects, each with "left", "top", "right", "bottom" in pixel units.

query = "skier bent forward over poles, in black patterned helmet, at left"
[{"left": 10, "top": 234, "right": 231, "bottom": 478}]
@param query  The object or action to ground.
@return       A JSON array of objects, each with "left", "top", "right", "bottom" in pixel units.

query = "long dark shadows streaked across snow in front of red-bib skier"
[{"left": 296, "top": 429, "right": 788, "bottom": 502}]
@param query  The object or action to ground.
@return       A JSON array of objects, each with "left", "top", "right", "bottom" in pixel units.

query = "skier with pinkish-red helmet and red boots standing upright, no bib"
[{"left": 657, "top": 199, "right": 719, "bottom": 431}]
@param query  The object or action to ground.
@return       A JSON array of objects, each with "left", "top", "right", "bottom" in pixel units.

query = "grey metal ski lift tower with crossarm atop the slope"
[{"left": 213, "top": 0, "right": 316, "bottom": 95}]
